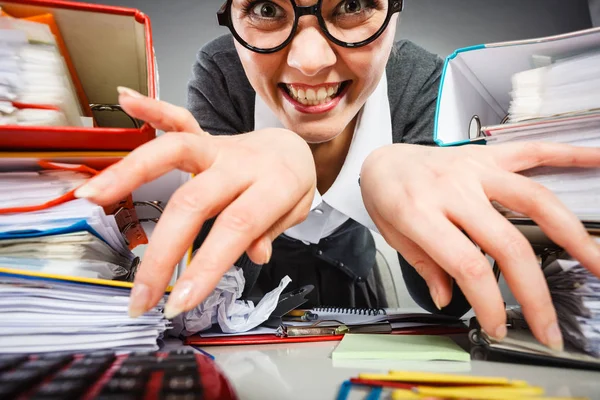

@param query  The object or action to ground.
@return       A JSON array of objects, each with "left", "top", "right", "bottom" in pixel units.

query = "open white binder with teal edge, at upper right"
[{"left": 434, "top": 28, "right": 600, "bottom": 146}]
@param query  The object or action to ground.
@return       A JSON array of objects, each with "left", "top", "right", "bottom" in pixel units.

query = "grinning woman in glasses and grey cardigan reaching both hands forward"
[{"left": 77, "top": 0, "right": 600, "bottom": 348}]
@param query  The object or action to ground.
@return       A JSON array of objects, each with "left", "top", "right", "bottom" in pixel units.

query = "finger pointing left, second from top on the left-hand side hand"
[{"left": 75, "top": 133, "right": 217, "bottom": 205}]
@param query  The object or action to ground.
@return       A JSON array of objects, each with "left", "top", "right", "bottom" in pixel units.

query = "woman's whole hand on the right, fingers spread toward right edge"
[{"left": 361, "top": 143, "right": 600, "bottom": 349}]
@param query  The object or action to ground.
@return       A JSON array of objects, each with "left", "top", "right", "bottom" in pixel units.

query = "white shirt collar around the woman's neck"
[{"left": 254, "top": 73, "right": 392, "bottom": 242}]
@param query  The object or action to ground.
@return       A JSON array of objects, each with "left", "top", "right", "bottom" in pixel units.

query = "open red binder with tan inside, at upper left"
[{"left": 0, "top": 0, "right": 156, "bottom": 151}]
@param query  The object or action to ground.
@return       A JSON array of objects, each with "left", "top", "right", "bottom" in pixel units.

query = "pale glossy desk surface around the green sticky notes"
[{"left": 190, "top": 342, "right": 600, "bottom": 400}]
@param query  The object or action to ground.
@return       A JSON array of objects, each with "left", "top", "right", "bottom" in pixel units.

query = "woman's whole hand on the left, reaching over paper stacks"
[{"left": 76, "top": 89, "right": 316, "bottom": 318}]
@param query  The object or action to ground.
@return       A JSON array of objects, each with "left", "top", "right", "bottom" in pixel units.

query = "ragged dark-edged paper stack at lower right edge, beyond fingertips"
[{"left": 543, "top": 253, "right": 600, "bottom": 357}]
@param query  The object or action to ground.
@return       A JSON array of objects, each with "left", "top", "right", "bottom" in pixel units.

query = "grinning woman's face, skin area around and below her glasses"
[{"left": 235, "top": 0, "right": 398, "bottom": 143}]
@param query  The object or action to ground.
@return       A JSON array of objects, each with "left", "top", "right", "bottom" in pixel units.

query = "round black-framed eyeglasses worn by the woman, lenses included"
[{"left": 217, "top": 0, "right": 404, "bottom": 54}]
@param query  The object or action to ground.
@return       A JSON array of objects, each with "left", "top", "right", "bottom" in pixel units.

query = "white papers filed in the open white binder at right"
[{"left": 482, "top": 52, "right": 600, "bottom": 221}]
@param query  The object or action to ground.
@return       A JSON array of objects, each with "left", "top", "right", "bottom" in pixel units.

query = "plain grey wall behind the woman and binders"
[{"left": 76, "top": 0, "right": 600, "bottom": 106}]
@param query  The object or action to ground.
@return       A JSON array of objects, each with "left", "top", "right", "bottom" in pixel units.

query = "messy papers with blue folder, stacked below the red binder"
[{"left": 0, "top": 171, "right": 136, "bottom": 280}]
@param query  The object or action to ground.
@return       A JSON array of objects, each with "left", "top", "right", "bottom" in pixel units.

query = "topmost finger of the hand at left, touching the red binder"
[{"left": 117, "top": 86, "right": 207, "bottom": 134}]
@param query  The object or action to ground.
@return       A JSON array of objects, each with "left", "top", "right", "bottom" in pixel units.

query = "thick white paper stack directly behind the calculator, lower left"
[{"left": 0, "top": 275, "right": 168, "bottom": 353}]
